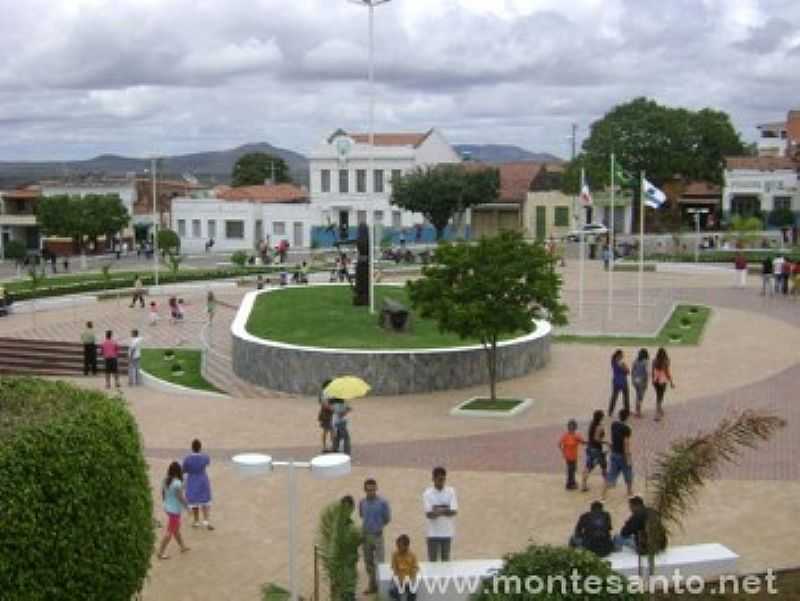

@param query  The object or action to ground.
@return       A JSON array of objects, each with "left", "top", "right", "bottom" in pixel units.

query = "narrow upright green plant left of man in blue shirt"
[{"left": 317, "top": 501, "right": 361, "bottom": 601}]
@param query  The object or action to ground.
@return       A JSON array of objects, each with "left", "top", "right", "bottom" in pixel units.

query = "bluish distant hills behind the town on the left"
[{"left": 0, "top": 142, "right": 308, "bottom": 187}]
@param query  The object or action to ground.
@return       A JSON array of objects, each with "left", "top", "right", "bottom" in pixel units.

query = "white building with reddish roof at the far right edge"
[{"left": 722, "top": 157, "right": 800, "bottom": 216}]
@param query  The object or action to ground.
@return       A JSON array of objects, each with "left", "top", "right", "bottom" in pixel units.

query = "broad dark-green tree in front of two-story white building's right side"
[{"left": 391, "top": 164, "right": 500, "bottom": 240}]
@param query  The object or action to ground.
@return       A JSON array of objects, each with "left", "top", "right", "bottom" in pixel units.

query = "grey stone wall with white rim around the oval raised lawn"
[{"left": 231, "top": 284, "right": 552, "bottom": 395}]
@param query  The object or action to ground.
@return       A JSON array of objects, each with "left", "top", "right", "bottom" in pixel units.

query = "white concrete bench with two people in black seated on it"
[{"left": 604, "top": 543, "right": 739, "bottom": 578}]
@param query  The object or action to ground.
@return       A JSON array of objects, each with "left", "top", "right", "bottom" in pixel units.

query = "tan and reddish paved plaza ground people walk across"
[{"left": 0, "top": 262, "right": 800, "bottom": 601}]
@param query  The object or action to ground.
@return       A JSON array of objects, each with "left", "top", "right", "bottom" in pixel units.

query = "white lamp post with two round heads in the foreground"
[{"left": 233, "top": 453, "right": 351, "bottom": 601}]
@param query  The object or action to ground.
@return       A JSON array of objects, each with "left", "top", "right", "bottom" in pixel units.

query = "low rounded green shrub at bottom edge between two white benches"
[{"left": 472, "top": 545, "right": 644, "bottom": 601}]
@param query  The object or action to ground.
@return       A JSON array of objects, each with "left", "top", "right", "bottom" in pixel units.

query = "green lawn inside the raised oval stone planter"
[{"left": 247, "top": 286, "right": 528, "bottom": 349}]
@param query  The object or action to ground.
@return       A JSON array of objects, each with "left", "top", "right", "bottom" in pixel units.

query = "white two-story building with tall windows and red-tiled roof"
[{"left": 309, "top": 128, "right": 461, "bottom": 245}]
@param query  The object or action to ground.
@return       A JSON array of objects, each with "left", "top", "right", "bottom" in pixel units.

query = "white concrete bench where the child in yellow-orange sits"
[{"left": 378, "top": 559, "right": 503, "bottom": 601}]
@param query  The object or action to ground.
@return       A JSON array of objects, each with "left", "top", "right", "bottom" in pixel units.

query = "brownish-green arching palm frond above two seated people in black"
[{"left": 648, "top": 410, "right": 786, "bottom": 534}]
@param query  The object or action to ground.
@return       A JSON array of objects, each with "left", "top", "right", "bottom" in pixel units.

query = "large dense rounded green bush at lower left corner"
[{"left": 0, "top": 378, "right": 155, "bottom": 601}]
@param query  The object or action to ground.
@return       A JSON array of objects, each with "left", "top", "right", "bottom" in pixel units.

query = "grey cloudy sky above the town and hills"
[{"left": 0, "top": 0, "right": 800, "bottom": 160}]
